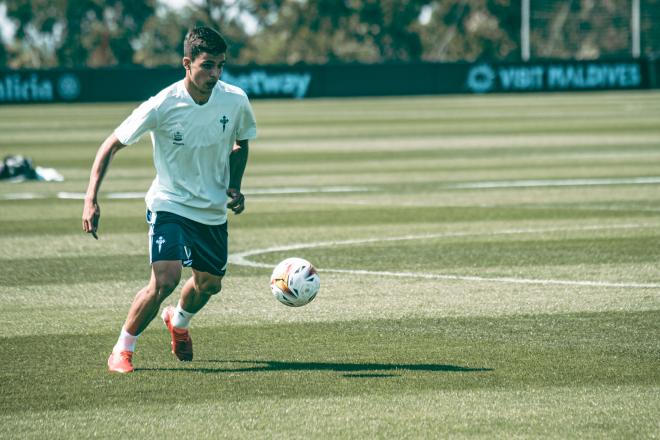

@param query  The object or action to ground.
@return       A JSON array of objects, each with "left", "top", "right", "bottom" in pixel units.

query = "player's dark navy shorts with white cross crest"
[{"left": 147, "top": 210, "right": 228, "bottom": 276}]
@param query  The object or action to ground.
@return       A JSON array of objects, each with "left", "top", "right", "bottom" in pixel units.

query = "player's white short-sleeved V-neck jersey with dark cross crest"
[{"left": 115, "top": 80, "right": 257, "bottom": 225}]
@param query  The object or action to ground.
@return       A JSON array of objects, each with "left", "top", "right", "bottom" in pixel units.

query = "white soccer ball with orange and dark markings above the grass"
[{"left": 270, "top": 257, "right": 321, "bottom": 307}]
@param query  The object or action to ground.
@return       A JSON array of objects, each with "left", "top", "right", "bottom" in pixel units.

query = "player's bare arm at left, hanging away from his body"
[{"left": 82, "top": 133, "right": 126, "bottom": 240}]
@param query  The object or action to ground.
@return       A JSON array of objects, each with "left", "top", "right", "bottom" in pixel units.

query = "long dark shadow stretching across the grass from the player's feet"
[{"left": 136, "top": 359, "right": 493, "bottom": 377}]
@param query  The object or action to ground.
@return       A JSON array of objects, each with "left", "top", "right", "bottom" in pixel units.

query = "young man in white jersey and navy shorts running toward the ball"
[{"left": 82, "top": 27, "right": 257, "bottom": 373}]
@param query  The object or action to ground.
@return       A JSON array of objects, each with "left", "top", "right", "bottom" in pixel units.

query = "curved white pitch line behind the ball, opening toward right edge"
[{"left": 229, "top": 224, "right": 660, "bottom": 289}]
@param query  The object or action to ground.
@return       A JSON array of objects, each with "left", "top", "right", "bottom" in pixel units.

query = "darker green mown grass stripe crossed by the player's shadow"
[{"left": 0, "top": 311, "right": 660, "bottom": 414}]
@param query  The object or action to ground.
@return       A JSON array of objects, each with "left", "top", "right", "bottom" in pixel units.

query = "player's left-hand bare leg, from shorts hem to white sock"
[{"left": 124, "top": 260, "right": 181, "bottom": 335}]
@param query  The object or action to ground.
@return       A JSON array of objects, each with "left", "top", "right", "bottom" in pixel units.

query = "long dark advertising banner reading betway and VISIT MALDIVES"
[{"left": 0, "top": 60, "right": 648, "bottom": 104}]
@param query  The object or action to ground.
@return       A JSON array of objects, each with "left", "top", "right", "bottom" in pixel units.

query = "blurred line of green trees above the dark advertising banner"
[{"left": 0, "top": 0, "right": 660, "bottom": 68}]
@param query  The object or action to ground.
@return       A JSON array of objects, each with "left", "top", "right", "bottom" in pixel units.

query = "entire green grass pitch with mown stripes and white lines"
[{"left": 0, "top": 92, "right": 660, "bottom": 439}]
